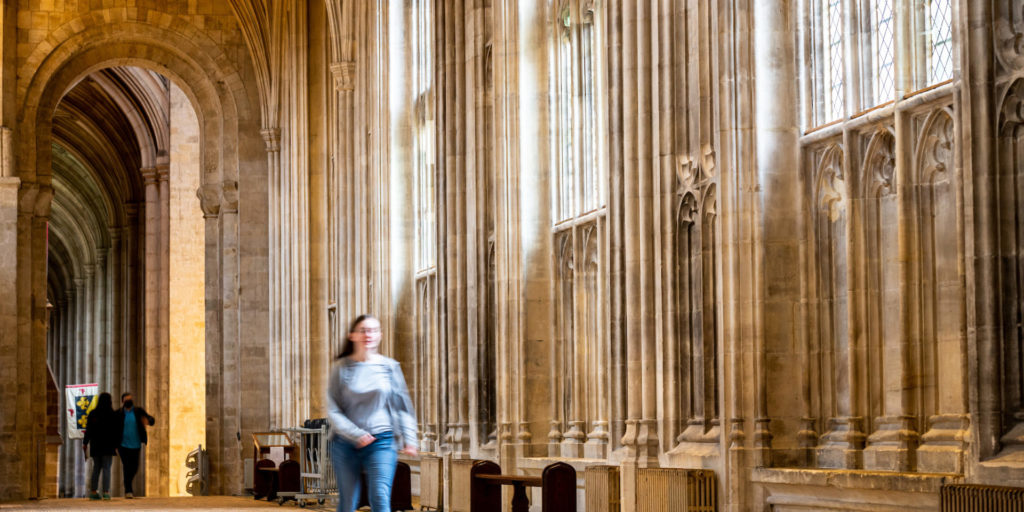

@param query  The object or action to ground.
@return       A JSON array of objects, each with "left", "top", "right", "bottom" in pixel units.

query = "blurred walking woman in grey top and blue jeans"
[{"left": 327, "top": 314, "right": 418, "bottom": 512}]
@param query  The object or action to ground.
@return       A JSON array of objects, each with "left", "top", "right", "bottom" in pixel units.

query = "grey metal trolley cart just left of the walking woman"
[{"left": 278, "top": 420, "right": 338, "bottom": 507}]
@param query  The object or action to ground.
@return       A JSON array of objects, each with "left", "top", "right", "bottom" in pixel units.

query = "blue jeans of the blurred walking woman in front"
[{"left": 331, "top": 432, "right": 398, "bottom": 512}]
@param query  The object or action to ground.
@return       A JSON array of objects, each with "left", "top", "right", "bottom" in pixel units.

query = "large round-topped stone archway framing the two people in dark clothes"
[{"left": 0, "top": 9, "right": 266, "bottom": 498}]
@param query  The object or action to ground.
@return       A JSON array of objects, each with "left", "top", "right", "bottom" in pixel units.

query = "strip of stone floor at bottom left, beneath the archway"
[{"left": 0, "top": 496, "right": 334, "bottom": 512}]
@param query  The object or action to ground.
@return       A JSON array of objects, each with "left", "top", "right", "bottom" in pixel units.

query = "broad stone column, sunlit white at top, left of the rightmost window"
[{"left": 746, "top": 2, "right": 798, "bottom": 466}]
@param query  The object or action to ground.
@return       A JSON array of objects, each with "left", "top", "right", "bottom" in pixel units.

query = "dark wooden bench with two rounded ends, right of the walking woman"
[{"left": 469, "top": 461, "right": 575, "bottom": 512}]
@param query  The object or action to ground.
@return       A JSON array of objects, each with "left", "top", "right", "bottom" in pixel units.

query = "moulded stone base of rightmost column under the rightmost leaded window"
[{"left": 918, "top": 415, "right": 966, "bottom": 474}]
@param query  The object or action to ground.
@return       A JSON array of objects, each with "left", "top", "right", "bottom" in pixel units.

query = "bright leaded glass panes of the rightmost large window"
[{"left": 802, "top": 0, "right": 953, "bottom": 128}]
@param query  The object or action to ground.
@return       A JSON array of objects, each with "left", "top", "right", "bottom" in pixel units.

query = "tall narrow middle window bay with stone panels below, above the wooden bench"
[{"left": 549, "top": 0, "right": 608, "bottom": 457}]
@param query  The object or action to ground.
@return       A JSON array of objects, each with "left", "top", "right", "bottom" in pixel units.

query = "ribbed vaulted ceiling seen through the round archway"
[{"left": 48, "top": 67, "right": 170, "bottom": 300}]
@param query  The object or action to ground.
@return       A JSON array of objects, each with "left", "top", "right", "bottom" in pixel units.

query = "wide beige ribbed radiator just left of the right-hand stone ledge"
[{"left": 637, "top": 468, "right": 718, "bottom": 512}]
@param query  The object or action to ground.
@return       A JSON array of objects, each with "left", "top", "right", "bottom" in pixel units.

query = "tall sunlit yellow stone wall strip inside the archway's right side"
[{"left": 168, "top": 85, "right": 206, "bottom": 496}]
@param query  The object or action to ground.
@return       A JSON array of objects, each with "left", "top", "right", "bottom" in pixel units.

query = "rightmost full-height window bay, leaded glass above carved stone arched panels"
[{"left": 800, "top": 0, "right": 967, "bottom": 473}]
